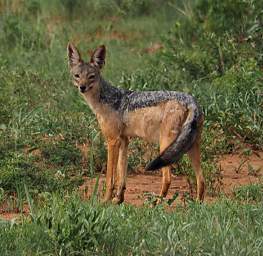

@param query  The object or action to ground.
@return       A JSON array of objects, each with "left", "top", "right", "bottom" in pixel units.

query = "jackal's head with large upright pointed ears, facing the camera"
[{"left": 67, "top": 43, "right": 106, "bottom": 93}]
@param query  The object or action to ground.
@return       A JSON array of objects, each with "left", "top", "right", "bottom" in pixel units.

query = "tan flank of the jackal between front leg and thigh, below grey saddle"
[{"left": 123, "top": 104, "right": 163, "bottom": 142}]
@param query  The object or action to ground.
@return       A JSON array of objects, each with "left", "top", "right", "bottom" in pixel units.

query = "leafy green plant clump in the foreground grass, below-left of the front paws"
[{"left": 35, "top": 196, "right": 110, "bottom": 255}]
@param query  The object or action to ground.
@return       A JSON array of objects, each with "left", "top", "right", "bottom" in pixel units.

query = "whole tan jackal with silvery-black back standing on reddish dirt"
[{"left": 67, "top": 44, "right": 205, "bottom": 203}]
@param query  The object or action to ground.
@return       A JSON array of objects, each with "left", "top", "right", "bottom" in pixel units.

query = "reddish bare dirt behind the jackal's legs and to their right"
[{"left": 80, "top": 152, "right": 263, "bottom": 206}]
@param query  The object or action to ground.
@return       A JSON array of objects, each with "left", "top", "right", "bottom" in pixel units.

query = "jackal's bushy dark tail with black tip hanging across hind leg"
[{"left": 145, "top": 105, "right": 200, "bottom": 171}]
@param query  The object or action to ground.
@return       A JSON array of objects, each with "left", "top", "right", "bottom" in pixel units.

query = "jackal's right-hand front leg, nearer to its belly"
[{"left": 112, "top": 138, "right": 129, "bottom": 204}]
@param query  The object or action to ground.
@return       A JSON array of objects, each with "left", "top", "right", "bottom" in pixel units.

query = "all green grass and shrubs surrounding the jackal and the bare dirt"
[{"left": 0, "top": 0, "right": 263, "bottom": 255}]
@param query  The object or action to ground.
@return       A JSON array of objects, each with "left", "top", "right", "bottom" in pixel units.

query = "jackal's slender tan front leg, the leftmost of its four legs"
[{"left": 103, "top": 139, "right": 120, "bottom": 202}]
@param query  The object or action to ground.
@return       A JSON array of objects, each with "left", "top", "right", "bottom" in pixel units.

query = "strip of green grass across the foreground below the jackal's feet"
[{"left": 0, "top": 195, "right": 263, "bottom": 255}]
